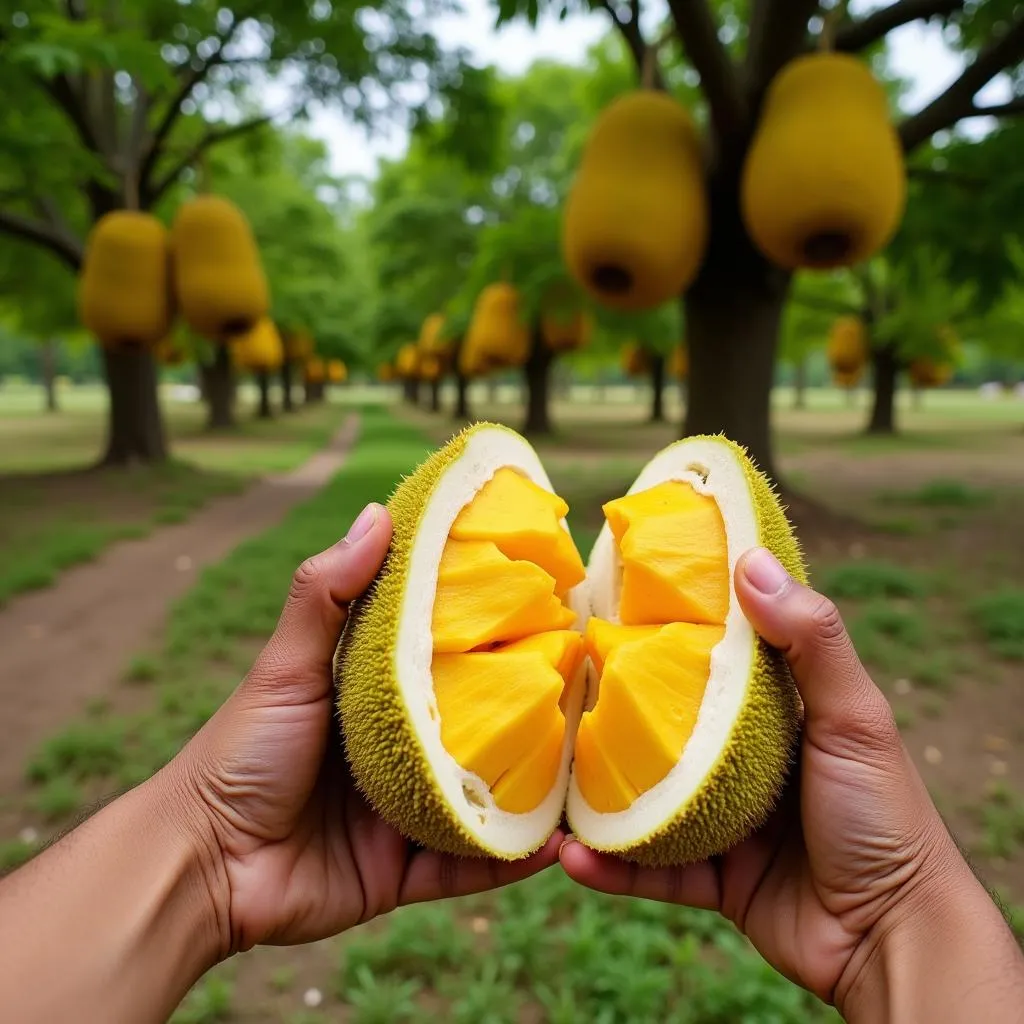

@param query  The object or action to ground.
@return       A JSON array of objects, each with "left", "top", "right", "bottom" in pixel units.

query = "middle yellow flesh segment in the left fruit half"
[{"left": 430, "top": 541, "right": 575, "bottom": 653}]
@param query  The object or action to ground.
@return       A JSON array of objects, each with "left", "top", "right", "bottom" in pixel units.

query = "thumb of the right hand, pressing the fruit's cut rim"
[{"left": 735, "top": 548, "right": 901, "bottom": 755}]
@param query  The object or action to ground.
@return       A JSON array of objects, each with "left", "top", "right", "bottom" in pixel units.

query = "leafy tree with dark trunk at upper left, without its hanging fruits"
[{"left": 0, "top": 0, "right": 451, "bottom": 463}]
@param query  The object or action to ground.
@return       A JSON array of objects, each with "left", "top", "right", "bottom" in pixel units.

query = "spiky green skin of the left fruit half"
[{"left": 335, "top": 423, "right": 531, "bottom": 856}]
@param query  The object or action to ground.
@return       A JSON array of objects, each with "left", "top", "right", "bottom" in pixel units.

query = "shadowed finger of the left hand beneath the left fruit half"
[{"left": 398, "top": 831, "right": 564, "bottom": 904}]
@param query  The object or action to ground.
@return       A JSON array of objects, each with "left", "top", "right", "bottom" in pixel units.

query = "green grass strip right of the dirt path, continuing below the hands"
[{"left": 19, "top": 403, "right": 836, "bottom": 1024}]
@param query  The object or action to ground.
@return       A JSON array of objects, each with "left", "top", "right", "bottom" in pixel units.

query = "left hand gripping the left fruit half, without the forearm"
[{"left": 169, "top": 505, "right": 561, "bottom": 957}]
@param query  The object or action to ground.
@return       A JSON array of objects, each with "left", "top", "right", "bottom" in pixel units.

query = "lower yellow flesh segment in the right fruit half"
[{"left": 575, "top": 623, "right": 725, "bottom": 811}]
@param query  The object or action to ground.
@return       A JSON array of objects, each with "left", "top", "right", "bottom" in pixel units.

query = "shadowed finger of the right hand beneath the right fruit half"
[{"left": 558, "top": 836, "right": 722, "bottom": 910}]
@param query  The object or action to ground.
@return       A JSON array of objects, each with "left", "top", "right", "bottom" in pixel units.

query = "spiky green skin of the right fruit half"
[{"left": 569, "top": 436, "right": 807, "bottom": 867}]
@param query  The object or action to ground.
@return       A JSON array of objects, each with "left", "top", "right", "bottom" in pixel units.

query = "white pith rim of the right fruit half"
[{"left": 565, "top": 439, "right": 758, "bottom": 850}]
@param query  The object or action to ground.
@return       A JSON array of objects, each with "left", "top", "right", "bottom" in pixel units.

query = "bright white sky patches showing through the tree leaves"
[{"left": 310, "top": 0, "right": 1005, "bottom": 177}]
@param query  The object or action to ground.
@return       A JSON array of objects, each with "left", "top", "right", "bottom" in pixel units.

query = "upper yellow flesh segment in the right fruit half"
[{"left": 604, "top": 480, "right": 729, "bottom": 626}]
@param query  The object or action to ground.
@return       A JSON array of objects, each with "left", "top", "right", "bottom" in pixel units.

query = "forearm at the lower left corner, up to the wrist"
[{"left": 0, "top": 767, "right": 224, "bottom": 1024}]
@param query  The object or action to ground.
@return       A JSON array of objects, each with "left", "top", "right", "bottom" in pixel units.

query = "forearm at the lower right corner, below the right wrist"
[{"left": 837, "top": 864, "right": 1024, "bottom": 1024}]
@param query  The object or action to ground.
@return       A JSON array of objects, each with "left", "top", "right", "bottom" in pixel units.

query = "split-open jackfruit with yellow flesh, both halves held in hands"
[{"left": 335, "top": 424, "right": 806, "bottom": 865}]
